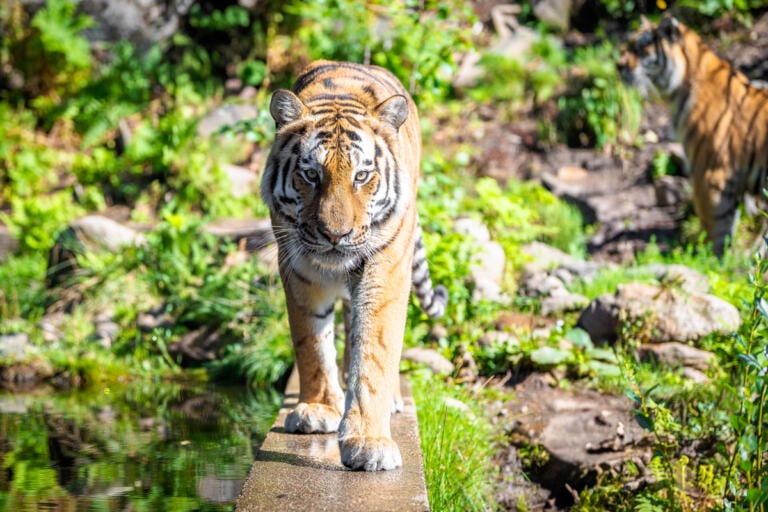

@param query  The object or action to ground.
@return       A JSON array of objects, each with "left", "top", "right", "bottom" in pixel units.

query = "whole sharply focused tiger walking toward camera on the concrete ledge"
[{"left": 261, "top": 61, "right": 447, "bottom": 471}]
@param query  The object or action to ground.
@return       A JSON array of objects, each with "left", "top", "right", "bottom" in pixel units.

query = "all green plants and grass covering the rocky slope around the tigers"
[{"left": 0, "top": 0, "right": 768, "bottom": 510}]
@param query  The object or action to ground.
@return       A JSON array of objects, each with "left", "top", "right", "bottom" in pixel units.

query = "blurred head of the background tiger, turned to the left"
[{"left": 616, "top": 16, "right": 688, "bottom": 97}]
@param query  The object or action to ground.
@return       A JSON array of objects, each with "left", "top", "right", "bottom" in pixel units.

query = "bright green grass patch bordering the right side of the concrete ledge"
[{"left": 410, "top": 372, "right": 494, "bottom": 511}]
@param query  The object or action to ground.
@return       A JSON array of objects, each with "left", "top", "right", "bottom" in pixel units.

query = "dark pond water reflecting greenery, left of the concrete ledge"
[{"left": 0, "top": 383, "right": 280, "bottom": 512}]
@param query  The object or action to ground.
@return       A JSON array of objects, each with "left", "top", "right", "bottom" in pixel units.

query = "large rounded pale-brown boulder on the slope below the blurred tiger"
[{"left": 577, "top": 283, "right": 741, "bottom": 343}]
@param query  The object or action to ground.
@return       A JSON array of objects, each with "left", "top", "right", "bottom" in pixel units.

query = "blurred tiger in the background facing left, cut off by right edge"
[{"left": 618, "top": 16, "right": 768, "bottom": 256}]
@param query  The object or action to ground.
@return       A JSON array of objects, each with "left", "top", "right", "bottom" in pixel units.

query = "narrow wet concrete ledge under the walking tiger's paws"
[{"left": 235, "top": 370, "right": 429, "bottom": 512}]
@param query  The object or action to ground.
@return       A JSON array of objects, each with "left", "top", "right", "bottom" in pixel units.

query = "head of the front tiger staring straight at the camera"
[{"left": 262, "top": 90, "right": 412, "bottom": 271}]
